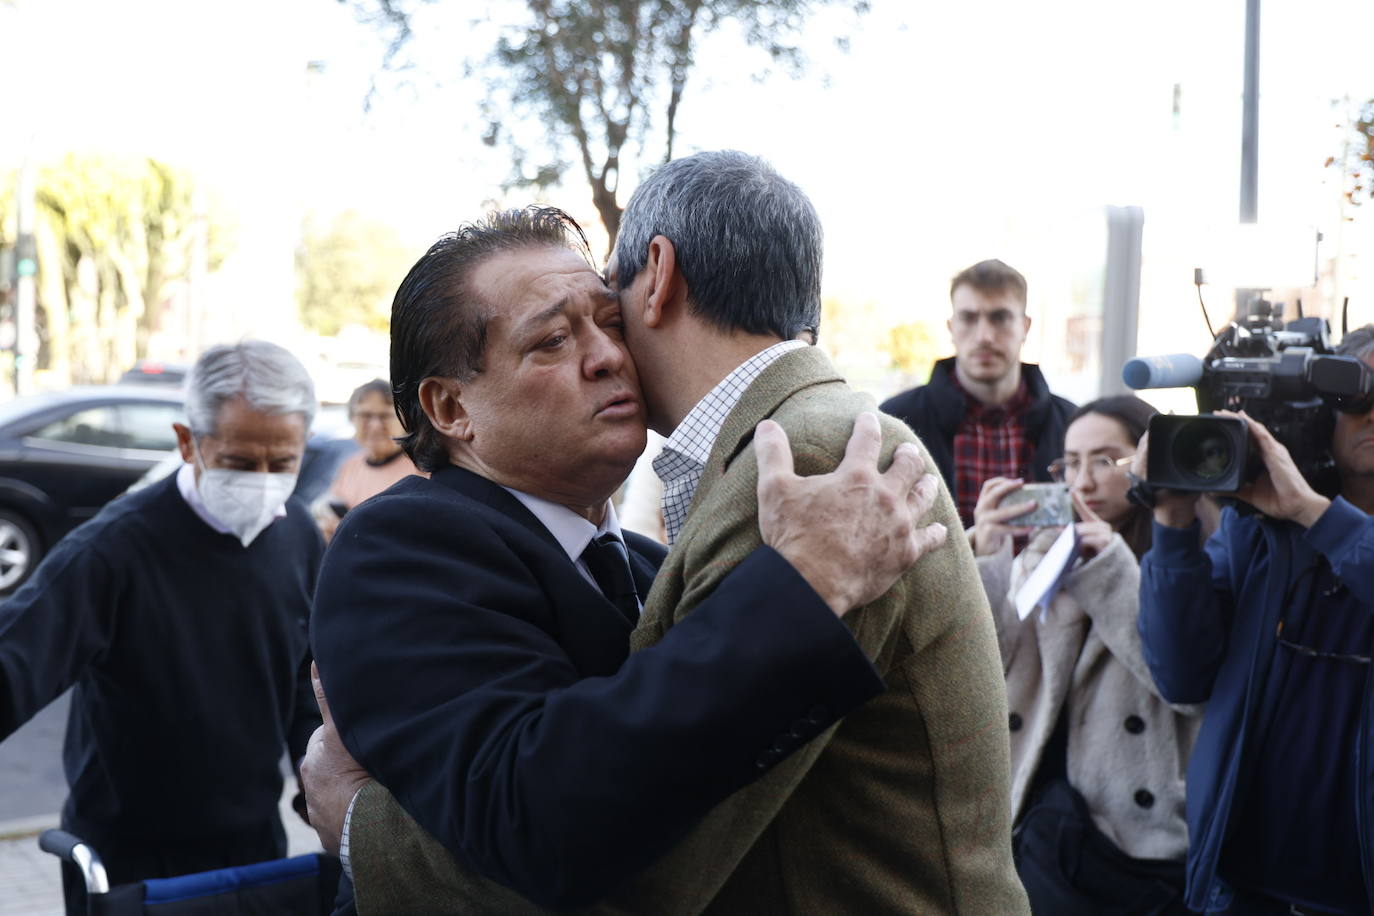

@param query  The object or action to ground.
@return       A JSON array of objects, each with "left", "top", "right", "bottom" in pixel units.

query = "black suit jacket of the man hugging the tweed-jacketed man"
[{"left": 312, "top": 467, "right": 883, "bottom": 905}]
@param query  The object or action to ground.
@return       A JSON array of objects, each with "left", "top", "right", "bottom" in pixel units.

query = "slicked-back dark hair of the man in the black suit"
[{"left": 392, "top": 206, "right": 595, "bottom": 471}]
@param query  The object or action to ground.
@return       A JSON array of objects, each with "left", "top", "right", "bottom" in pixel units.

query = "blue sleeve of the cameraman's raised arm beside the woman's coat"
[{"left": 1138, "top": 509, "right": 1253, "bottom": 705}]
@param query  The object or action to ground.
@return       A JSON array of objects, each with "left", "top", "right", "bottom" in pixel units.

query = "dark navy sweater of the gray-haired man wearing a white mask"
[{"left": 0, "top": 475, "right": 323, "bottom": 847}]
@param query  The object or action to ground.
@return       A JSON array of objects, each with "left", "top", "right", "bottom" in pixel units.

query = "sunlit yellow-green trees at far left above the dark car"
[{"left": 0, "top": 154, "right": 229, "bottom": 382}]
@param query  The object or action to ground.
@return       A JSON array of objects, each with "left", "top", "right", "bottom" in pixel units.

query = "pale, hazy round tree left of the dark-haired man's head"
[{"left": 295, "top": 210, "right": 415, "bottom": 336}]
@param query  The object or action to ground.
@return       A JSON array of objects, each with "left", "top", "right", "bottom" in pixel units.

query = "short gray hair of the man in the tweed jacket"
[{"left": 616, "top": 150, "right": 822, "bottom": 339}]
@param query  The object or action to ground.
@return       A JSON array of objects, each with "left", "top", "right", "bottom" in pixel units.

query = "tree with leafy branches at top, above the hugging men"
[{"left": 339, "top": 0, "right": 868, "bottom": 245}]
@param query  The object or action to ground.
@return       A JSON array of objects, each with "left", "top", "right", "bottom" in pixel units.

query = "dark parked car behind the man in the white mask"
[{"left": 0, "top": 385, "right": 357, "bottom": 596}]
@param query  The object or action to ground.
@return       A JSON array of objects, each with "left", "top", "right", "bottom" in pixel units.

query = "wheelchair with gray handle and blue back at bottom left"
[{"left": 38, "top": 829, "right": 341, "bottom": 916}]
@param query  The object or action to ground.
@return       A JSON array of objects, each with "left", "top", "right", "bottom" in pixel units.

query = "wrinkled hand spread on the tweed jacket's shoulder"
[{"left": 754, "top": 413, "right": 947, "bottom": 617}]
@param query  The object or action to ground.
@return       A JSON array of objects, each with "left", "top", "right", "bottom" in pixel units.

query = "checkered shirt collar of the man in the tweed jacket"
[{"left": 654, "top": 341, "right": 807, "bottom": 544}]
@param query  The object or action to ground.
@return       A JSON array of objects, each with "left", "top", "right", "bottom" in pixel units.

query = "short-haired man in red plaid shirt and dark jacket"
[{"left": 882, "top": 260, "right": 1074, "bottom": 527}]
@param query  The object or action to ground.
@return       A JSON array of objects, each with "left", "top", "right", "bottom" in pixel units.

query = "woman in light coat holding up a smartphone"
[{"left": 970, "top": 396, "right": 1201, "bottom": 916}]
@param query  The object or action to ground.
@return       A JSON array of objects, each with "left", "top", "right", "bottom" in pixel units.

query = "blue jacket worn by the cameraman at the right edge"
[{"left": 1139, "top": 497, "right": 1374, "bottom": 912}]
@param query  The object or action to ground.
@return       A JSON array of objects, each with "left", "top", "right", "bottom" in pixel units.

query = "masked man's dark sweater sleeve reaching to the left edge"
[{"left": 0, "top": 526, "right": 124, "bottom": 740}]
